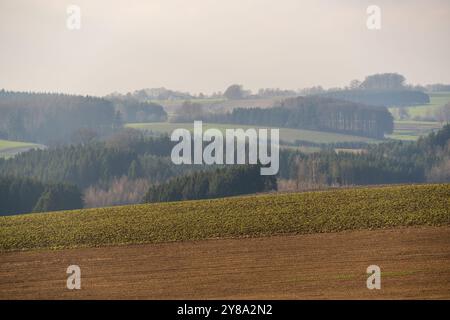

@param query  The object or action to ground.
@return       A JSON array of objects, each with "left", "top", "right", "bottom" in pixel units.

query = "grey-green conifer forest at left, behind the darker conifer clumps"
[{"left": 0, "top": 133, "right": 183, "bottom": 189}]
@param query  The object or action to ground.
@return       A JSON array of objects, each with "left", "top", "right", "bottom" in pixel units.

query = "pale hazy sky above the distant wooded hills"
[{"left": 0, "top": 0, "right": 450, "bottom": 95}]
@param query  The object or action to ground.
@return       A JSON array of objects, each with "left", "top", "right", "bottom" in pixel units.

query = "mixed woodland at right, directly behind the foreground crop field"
[{"left": 279, "top": 125, "right": 450, "bottom": 189}]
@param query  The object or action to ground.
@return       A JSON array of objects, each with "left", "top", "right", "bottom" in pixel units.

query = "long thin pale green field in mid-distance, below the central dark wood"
[{"left": 126, "top": 122, "right": 377, "bottom": 143}]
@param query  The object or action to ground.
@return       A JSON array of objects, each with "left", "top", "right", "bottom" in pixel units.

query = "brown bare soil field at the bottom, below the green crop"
[{"left": 0, "top": 227, "right": 450, "bottom": 299}]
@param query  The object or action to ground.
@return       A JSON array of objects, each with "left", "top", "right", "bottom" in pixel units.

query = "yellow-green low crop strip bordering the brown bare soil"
[{"left": 0, "top": 184, "right": 450, "bottom": 250}]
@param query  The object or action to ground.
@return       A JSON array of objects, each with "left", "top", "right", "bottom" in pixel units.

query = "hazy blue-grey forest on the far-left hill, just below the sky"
[{"left": 0, "top": 90, "right": 115, "bottom": 144}]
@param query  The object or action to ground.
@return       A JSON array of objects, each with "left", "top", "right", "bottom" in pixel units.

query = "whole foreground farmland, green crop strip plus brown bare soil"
[{"left": 0, "top": 184, "right": 450, "bottom": 299}]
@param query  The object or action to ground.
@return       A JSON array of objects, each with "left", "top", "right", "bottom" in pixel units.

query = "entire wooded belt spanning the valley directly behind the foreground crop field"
[{"left": 0, "top": 125, "right": 450, "bottom": 214}]
